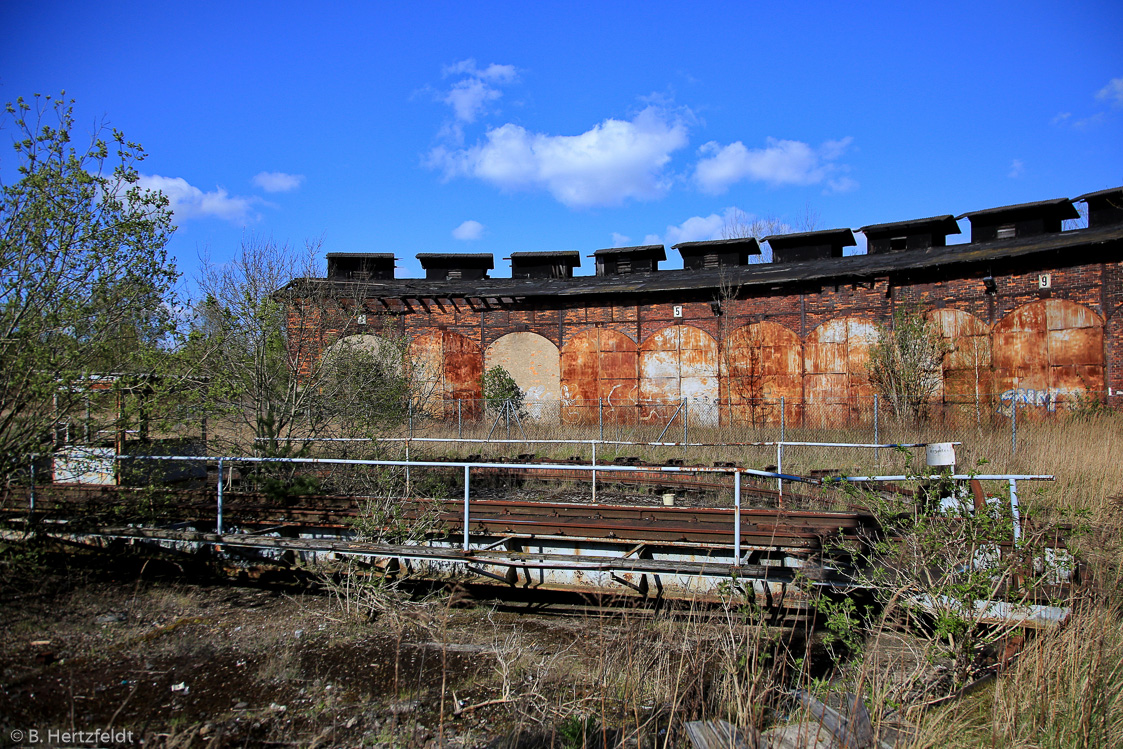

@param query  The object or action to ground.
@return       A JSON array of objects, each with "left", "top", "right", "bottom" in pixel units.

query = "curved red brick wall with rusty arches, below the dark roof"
[{"left": 290, "top": 254, "right": 1123, "bottom": 426}]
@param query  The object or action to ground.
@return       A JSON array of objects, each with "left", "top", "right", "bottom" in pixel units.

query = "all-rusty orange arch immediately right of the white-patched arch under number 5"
[{"left": 721, "top": 322, "right": 803, "bottom": 426}]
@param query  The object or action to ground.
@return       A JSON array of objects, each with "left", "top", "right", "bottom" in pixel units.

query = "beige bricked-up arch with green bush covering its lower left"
[{"left": 484, "top": 331, "right": 562, "bottom": 418}]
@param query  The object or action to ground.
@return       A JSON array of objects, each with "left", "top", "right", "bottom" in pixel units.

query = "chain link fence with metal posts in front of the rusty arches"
[{"left": 395, "top": 391, "right": 1111, "bottom": 475}]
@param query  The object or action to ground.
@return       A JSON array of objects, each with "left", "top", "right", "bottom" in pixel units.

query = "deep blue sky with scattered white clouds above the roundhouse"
[{"left": 0, "top": 0, "right": 1123, "bottom": 276}]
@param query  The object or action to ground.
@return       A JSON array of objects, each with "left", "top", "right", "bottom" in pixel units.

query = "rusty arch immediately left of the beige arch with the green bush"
[{"left": 410, "top": 330, "right": 484, "bottom": 417}]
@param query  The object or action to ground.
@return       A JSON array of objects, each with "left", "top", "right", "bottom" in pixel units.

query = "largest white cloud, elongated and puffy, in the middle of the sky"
[{"left": 426, "top": 107, "right": 687, "bottom": 208}]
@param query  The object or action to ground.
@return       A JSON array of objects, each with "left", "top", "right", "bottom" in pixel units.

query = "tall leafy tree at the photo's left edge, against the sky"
[{"left": 0, "top": 94, "right": 177, "bottom": 474}]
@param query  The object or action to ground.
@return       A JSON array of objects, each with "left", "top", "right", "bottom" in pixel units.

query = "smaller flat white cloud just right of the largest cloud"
[{"left": 694, "top": 137, "right": 858, "bottom": 194}]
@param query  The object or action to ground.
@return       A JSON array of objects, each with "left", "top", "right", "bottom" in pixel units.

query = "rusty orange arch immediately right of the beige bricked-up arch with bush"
[{"left": 562, "top": 328, "right": 639, "bottom": 423}]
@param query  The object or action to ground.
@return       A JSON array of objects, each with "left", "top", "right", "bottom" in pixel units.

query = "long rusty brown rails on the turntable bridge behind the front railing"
[{"left": 0, "top": 486, "right": 878, "bottom": 554}]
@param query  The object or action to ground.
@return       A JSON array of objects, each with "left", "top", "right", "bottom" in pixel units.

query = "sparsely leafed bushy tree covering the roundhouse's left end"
[{"left": 183, "top": 237, "right": 412, "bottom": 457}]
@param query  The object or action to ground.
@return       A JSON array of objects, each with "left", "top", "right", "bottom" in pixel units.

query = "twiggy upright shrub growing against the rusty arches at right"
[{"left": 869, "top": 307, "right": 949, "bottom": 426}]
